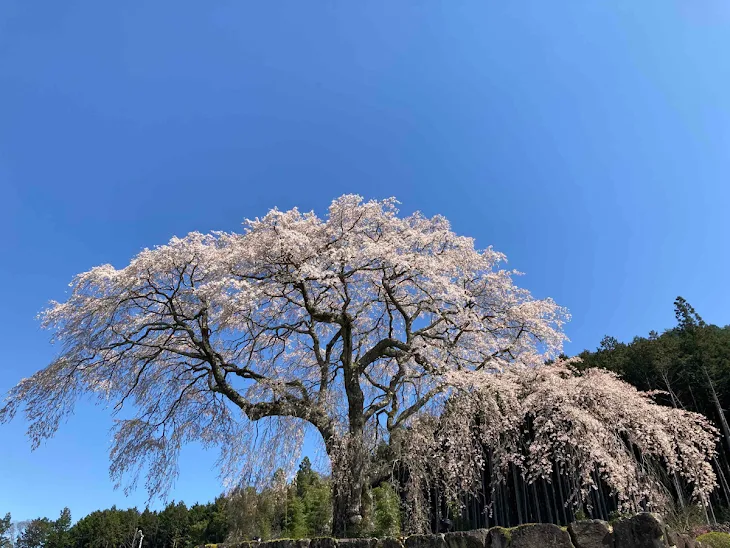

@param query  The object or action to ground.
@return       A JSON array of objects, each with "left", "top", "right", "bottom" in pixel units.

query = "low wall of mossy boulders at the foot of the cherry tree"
[{"left": 199, "top": 513, "right": 702, "bottom": 548}]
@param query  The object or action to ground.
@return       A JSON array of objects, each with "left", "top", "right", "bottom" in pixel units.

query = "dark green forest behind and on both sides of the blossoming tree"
[{"left": 5, "top": 297, "right": 730, "bottom": 548}]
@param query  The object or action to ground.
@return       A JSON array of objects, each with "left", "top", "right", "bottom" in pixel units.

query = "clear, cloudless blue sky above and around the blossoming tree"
[{"left": 0, "top": 0, "right": 730, "bottom": 519}]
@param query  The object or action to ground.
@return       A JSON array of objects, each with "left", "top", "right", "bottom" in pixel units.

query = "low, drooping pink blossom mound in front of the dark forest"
[{"left": 399, "top": 361, "right": 717, "bottom": 531}]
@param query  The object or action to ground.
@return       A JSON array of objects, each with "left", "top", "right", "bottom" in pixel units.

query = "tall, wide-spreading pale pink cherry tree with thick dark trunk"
[{"left": 0, "top": 195, "right": 566, "bottom": 534}]
